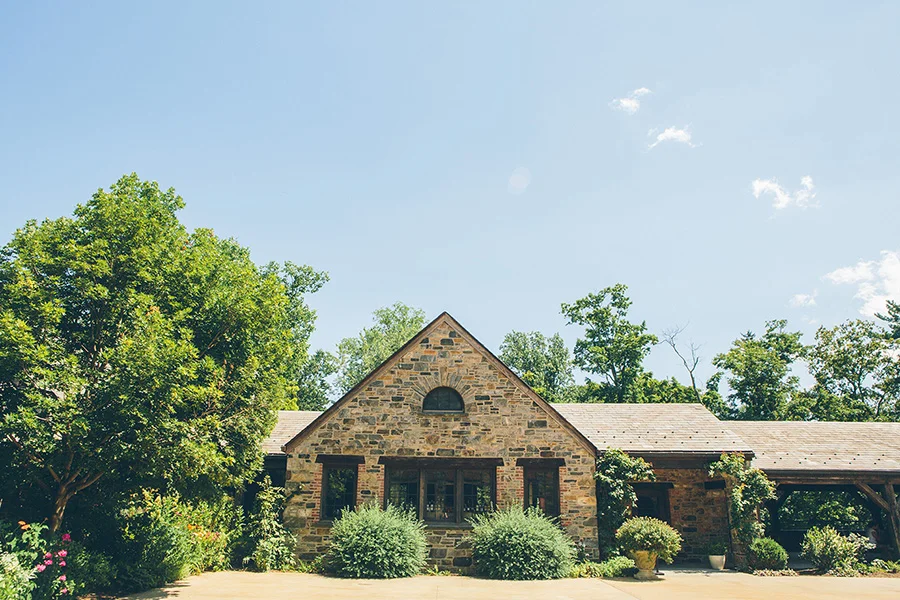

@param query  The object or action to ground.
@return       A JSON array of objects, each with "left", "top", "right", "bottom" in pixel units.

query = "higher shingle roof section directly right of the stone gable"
[{"left": 553, "top": 404, "right": 752, "bottom": 454}]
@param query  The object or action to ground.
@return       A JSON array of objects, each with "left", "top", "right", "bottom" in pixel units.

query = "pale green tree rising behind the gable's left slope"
[{"left": 337, "top": 302, "right": 425, "bottom": 393}]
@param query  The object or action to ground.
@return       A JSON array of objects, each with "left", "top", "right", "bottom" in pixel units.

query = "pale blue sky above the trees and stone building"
[{"left": 0, "top": 2, "right": 900, "bottom": 384}]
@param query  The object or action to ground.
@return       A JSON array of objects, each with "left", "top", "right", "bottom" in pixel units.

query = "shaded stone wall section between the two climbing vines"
[{"left": 653, "top": 467, "right": 730, "bottom": 562}]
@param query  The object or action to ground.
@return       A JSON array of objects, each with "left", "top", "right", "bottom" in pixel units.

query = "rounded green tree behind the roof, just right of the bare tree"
[{"left": 713, "top": 320, "right": 803, "bottom": 421}]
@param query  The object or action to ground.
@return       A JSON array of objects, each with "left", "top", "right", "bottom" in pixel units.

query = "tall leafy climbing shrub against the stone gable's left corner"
[{"left": 243, "top": 476, "right": 298, "bottom": 571}]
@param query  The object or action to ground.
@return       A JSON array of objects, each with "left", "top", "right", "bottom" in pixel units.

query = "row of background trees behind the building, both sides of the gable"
[{"left": 325, "top": 284, "right": 900, "bottom": 421}]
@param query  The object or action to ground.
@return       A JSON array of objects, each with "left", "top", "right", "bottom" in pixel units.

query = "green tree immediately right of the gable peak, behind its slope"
[{"left": 500, "top": 331, "right": 575, "bottom": 402}]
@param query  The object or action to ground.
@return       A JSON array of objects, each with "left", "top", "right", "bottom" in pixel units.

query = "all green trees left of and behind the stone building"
[{"left": 0, "top": 174, "right": 900, "bottom": 529}]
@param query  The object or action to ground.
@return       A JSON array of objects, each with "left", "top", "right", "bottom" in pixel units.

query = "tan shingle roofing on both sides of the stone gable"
[{"left": 262, "top": 404, "right": 900, "bottom": 475}]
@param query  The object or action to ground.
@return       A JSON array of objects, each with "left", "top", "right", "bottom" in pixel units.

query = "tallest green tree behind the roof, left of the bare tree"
[{"left": 562, "top": 283, "right": 658, "bottom": 402}]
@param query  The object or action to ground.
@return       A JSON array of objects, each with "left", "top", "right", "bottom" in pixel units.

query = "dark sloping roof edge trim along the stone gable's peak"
[{"left": 281, "top": 311, "right": 597, "bottom": 453}]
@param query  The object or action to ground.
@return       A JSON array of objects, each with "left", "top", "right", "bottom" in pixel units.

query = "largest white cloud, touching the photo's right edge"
[{"left": 825, "top": 250, "right": 900, "bottom": 317}]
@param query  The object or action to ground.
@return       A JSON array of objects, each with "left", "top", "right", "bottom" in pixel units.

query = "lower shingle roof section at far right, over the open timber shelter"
[{"left": 728, "top": 421, "right": 900, "bottom": 472}]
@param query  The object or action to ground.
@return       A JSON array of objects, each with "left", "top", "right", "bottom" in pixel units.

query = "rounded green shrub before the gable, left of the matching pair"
[{"left": 326, "top": 505, "right": 428, "bottom": 579}]
